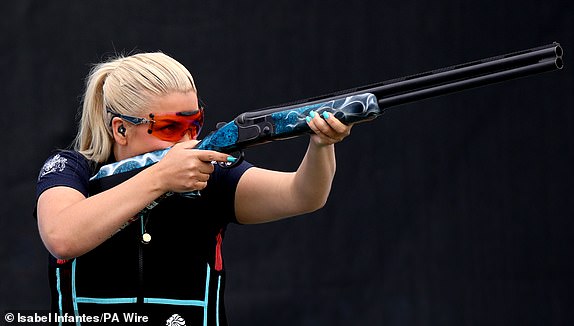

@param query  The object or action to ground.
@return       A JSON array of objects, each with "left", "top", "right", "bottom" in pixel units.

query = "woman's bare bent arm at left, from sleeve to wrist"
[{"left": 38, "top": 167, "right": 164, "bottom": 258}]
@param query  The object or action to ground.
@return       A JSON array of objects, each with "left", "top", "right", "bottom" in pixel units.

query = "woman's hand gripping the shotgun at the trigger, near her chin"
[{"left": 150, "top": 140, "right": 234, "bottom": 192}]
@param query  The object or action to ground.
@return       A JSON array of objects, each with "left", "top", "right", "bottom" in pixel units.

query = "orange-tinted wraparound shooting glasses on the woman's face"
[{"left": 107, "top": 107, "right": 203, "bottom": 142}]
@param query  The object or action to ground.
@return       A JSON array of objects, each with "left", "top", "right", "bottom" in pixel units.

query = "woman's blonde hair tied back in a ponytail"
[{"left": 74, "top": 52, "right": 197, "bottom": 163}]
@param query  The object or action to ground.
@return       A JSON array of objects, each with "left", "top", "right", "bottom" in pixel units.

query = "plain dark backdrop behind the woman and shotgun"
[{"left": 0, "top": 0, "right": 574, "bottom": 325}]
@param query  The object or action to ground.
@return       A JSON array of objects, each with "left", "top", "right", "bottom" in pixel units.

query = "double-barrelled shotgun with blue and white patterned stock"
[{"left": 90, "top": 42, "right": 563, "bottom": 197}]
